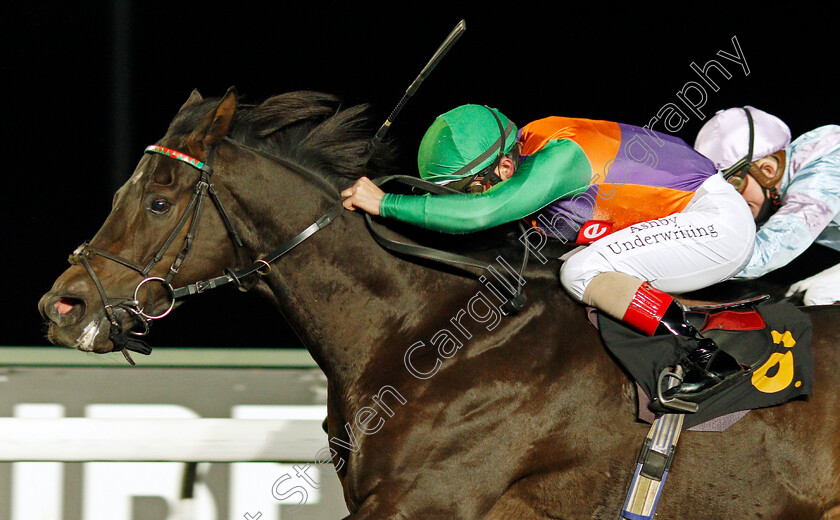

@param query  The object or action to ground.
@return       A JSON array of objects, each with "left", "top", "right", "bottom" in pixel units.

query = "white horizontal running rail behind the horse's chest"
[{"left": 0, "top": 417, "right": 327, "bottom": 462}]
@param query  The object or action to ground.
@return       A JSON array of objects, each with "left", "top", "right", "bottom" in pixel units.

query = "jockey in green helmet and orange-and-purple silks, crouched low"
[{"left": 341, "top": 105, "right": 754, "bottom": 402}]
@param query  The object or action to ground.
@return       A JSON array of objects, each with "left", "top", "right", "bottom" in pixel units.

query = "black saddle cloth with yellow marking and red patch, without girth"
[{"left": 598, "top": 303, "right": 814, "bottom": 428}]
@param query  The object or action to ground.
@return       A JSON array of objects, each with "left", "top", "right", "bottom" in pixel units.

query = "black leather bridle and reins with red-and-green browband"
[{"left": 75, "top": 138, "right": 528, "bottom": 365}]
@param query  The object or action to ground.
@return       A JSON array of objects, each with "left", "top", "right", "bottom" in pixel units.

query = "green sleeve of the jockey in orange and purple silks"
[{"left": 379, "top": 139, "right": 592, "bottom": 234}]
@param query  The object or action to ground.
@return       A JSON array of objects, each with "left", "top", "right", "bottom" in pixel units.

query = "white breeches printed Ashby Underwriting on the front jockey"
[{"left": 560, "top": 175, "right": 755, "bottom": 301}]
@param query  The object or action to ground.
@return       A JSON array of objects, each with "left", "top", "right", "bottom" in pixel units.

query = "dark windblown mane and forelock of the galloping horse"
[{"left": 167, "top": 91, "right": 396, "bottom": 187}]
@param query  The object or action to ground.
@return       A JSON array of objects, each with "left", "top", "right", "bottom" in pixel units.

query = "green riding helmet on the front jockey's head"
[{"left": 417, "top": 105, "right": 517, "bottom": 184}]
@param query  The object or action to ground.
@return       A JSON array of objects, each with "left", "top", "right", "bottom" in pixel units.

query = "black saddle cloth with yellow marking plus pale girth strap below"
[{"left": 597, "top": 297, "right": 814, "bottom": 520}]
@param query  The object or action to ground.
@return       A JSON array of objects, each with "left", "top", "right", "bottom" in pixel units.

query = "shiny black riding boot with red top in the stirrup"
[{"left": 624, "top": 283, "right": 745, "bottom": 402}]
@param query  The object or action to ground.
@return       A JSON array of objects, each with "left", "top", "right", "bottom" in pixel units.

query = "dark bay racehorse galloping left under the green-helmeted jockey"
[{"left": 39, "top": 90, "right": 840, "bottom": 520}]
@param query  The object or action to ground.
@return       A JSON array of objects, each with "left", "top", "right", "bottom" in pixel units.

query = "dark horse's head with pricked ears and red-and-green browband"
[{"left": 39, "top": 89, "right": 244, "bottom": 352}]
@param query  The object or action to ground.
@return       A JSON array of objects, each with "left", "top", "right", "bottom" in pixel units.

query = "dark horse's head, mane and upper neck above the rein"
[{"left": 39, "top": 88, "right": 402, "bottom": 362}]
